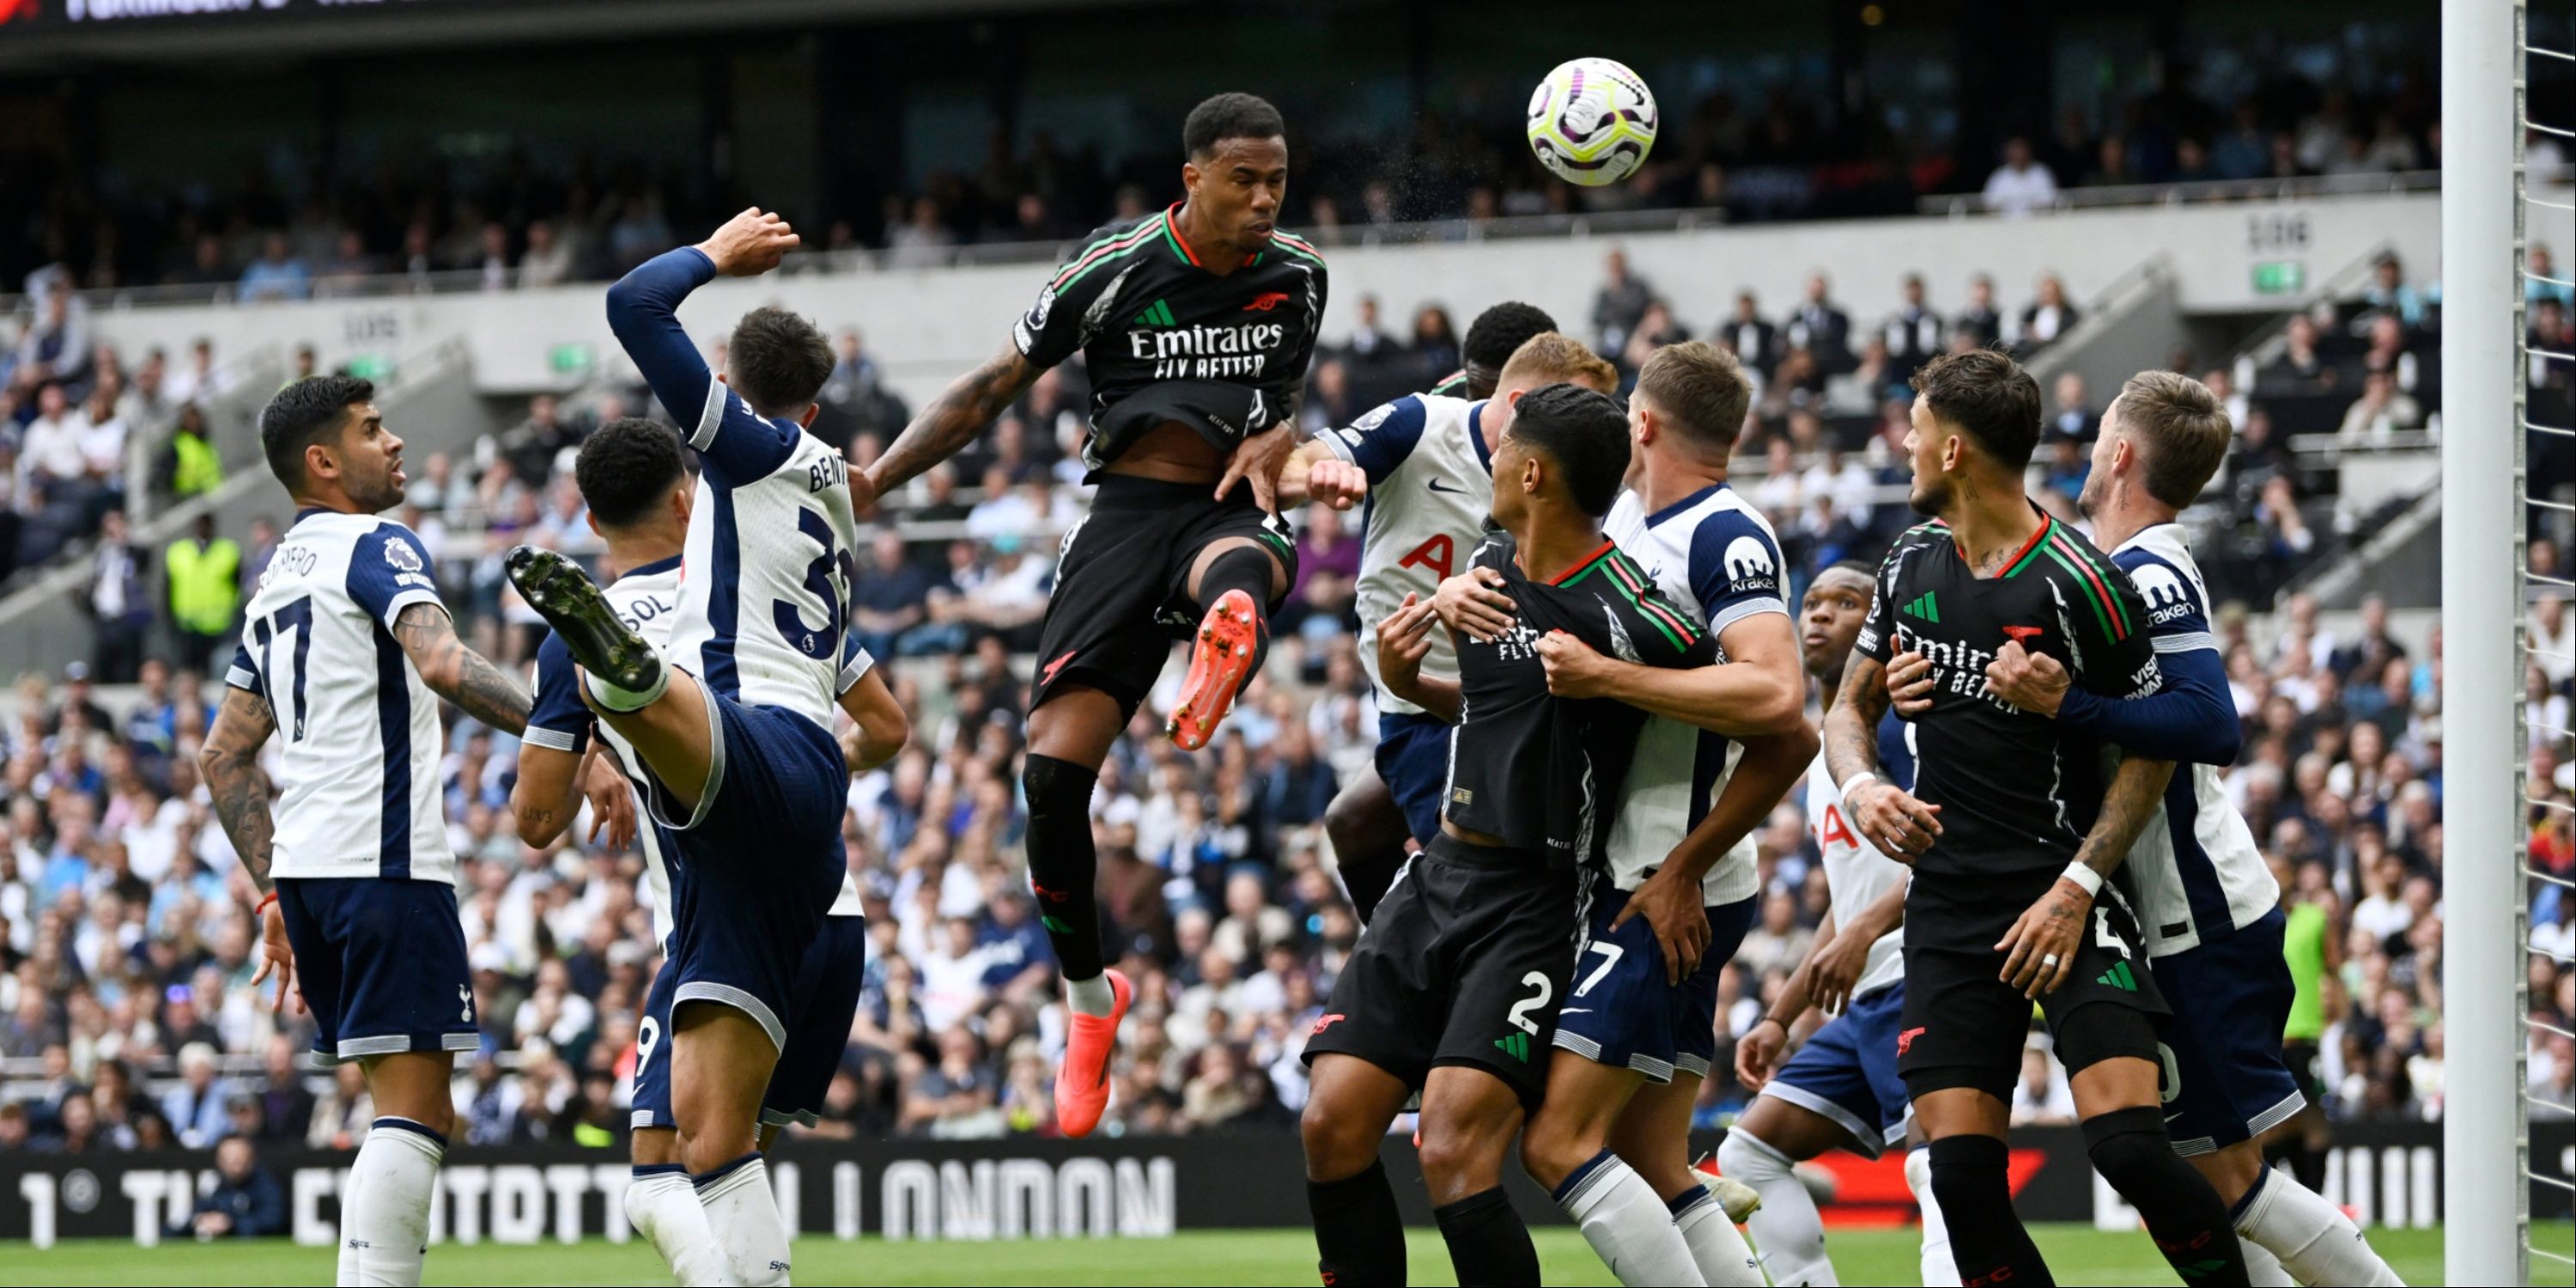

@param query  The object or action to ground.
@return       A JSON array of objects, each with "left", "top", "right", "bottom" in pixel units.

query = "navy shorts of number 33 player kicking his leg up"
[{"left": 647, "top": 693, "right": 850, "bottom": 1051}]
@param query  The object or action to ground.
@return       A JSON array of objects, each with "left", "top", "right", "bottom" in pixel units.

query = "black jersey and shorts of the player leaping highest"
[{"left": 1012, "top": 206, "right": 1327, "bottom": 711}]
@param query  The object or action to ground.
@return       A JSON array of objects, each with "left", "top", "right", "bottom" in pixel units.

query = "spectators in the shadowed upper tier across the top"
[{"left": 0, "top": 33, "right": 2524, "bottom": 301}]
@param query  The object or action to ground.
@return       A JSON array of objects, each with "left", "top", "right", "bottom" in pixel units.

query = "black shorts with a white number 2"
[{"left": 1306, "top": 835, "right": 1582, "bottom": 1105}]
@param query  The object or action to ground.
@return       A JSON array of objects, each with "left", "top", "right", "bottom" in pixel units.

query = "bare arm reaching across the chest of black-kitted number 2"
[{"left": 1538, "top": 613, "right": 1814, "bottom": 737}]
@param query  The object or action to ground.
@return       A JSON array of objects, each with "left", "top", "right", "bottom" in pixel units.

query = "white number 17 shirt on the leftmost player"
[{"left": 224, "top": 510, "right": 456, "bottom": 881}]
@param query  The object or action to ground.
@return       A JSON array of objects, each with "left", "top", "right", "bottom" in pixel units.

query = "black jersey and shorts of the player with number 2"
[{"left": 1306, "top": 533, "right": 1718, "bottom": 1105}]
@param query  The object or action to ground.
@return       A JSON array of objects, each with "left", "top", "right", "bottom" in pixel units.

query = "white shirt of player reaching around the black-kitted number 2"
[{"left": 1602, "top": 484, "right": 1788, "bottom": 907}]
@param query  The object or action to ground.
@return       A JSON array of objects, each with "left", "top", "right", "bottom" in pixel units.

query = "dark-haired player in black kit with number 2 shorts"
[{"left": 1301, "top": 381, "right": 1716, "bottom": 1283}]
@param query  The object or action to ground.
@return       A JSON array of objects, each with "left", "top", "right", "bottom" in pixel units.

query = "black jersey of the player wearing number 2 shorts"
[{"left": 1443, "top": 531, "right": 1718, "bottom": 863}]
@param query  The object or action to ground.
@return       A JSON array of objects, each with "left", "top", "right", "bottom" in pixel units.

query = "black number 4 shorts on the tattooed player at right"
[{"left": 1896, "top": 878, "right": 2172, "bottom": 1103}]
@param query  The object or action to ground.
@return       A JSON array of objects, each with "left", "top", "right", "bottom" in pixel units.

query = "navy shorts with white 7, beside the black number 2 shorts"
[{"left": 1556, "top": 881, "right": 1762, "bottom": 1082}]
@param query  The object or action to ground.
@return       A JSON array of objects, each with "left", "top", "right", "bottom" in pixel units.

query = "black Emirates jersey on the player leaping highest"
[{"left": 1010, "top": 206, "right": 1327, "bottom": 469}]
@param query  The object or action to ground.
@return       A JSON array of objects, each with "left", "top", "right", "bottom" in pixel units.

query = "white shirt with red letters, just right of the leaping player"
[{"left": 1316, "top": 394, "right": 1494, "bottom": 714}]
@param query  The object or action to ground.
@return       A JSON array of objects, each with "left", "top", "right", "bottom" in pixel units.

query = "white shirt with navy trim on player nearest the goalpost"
[{"left": 2110, "top": 523, "right": 2280, "bottom": 958}]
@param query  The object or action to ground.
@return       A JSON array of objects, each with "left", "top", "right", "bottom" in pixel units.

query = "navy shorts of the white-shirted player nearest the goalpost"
[{"left": 2148, "top": 907, "right": 2308, "bottom": 1154}]
